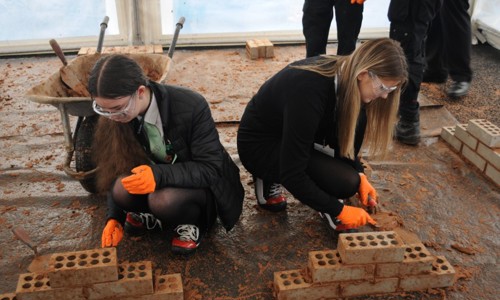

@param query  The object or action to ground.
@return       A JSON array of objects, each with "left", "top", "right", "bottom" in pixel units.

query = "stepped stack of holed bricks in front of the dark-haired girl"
[{"left": 0, "top": 248, "right": 184, "bottom": 300}]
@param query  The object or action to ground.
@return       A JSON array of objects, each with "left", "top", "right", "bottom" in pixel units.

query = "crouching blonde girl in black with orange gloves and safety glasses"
[{"left": 238, "top": 38, "right": 408, "bottom": 229}]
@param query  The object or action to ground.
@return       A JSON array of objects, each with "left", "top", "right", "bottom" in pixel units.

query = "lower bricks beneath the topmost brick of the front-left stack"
[{"left": 12, "top": 261, "right": 184, "bottom": 300}]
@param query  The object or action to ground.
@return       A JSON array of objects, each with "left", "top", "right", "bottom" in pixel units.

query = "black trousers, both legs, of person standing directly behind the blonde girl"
[{"left": 302, "top": 0, "right": 363, "bottom": 57}]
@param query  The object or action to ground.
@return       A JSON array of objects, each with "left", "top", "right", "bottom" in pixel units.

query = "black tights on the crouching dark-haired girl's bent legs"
[{"left": 112, "top": 178, "right": 215, "bottom": 230}]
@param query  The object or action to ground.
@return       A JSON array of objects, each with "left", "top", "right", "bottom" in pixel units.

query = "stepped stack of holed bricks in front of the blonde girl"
[{"left": 274, "top": 231, "right": 455, "bottom": 300}]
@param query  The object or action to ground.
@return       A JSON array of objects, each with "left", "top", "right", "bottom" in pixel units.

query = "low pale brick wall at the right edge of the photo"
[{"left": 441, "top": 119, "right": 500, "bottom": 186}]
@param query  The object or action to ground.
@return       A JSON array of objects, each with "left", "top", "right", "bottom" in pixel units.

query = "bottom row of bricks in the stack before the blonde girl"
[{"left": 274, "top": 256, "right": 455, "bottom": 300}]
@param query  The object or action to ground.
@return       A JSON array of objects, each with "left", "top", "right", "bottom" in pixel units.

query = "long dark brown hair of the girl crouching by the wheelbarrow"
[{"left": 89, "top": 54, "right": 150, "bottom": 192}]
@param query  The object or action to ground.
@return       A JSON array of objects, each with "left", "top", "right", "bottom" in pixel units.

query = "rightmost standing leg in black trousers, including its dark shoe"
[{"left": 441, "top": 0, "right": 472, "bottom": 97}]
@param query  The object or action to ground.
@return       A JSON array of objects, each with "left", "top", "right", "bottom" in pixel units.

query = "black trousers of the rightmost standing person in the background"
[{"left": 425, "top": 0, "right": 472, "bottom": 82}]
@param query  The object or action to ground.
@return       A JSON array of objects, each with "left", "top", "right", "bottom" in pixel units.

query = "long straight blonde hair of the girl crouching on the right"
[{"left": 296, "top": 38, "right": 408, "bottom": 158}]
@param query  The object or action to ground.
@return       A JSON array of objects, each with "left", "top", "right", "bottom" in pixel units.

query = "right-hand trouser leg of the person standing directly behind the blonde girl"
[{"left": 335, "top": 0, "right": 364, "bottom": 55}]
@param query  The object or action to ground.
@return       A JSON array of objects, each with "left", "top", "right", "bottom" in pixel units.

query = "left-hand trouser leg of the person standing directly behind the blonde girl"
[{"left": 302, "top": 0, "right": 335, "bottom": 57}]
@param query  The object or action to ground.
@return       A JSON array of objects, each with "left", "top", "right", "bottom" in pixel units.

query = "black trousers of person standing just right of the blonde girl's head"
[{"left": 388, "top": 0, "right": 443, "bottom": 122}]
